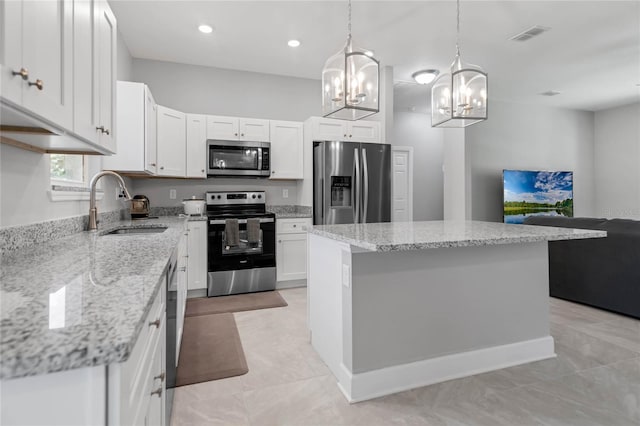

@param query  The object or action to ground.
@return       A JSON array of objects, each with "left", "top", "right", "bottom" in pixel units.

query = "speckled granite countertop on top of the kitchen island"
[{"left": 308, "top": 221, "right": 607, "bottom": 252}]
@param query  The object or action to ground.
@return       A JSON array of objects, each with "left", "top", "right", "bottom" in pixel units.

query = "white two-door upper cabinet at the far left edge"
[{"left": 0, "top": 0, "right": 73, "bottom": 129}]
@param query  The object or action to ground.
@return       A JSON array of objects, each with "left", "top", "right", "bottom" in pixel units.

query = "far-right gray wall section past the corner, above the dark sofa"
[{"left": 594, "top": 103, "right": 640, "bottom": 219}]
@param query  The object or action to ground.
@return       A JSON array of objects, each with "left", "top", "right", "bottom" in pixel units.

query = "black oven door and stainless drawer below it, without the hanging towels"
[{"left": 207, "top": 217, "right": 276, "bottom": 296}]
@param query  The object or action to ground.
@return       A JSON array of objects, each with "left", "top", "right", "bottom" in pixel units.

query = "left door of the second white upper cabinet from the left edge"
[{"left": 73, "top": 0, "right": 100, "bottom": 143}]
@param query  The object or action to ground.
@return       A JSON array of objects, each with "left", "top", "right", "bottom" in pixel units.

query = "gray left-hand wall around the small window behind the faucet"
[{"left": 0, "top": 36, "right": 132, "bottom": 226}]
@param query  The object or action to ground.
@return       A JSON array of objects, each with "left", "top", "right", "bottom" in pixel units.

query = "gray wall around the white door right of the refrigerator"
[{"left": 391, "top": 111, "right": 443, "bottom": 221}]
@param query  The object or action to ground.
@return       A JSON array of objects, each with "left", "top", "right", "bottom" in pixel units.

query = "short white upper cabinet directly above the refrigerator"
[{"left": 309, "top": 117, "right": 382, "bottom": 143}]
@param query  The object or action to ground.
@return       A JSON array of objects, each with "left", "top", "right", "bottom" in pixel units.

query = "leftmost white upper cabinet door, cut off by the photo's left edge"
[{"left": 0, "top": 1, "right": 23, "bottom": 105}]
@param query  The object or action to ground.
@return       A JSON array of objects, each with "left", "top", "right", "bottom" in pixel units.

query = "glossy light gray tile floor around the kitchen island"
[{"left": 171, "top": 288, "right": 640, "bottom": 426}]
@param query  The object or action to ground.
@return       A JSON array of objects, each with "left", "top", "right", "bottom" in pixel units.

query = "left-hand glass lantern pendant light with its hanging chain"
[{"left": 322, "top": 0, "right": 380, "bottom": 120}]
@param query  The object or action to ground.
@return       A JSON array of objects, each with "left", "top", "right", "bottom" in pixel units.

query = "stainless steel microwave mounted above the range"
[{"left": 207, "top": 139, "right": 271, "bottom": 177}]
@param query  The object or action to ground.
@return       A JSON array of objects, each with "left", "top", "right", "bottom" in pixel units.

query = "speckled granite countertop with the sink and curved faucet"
[{"left": 0, "top": 217, "right": 185, "bottom": 379}]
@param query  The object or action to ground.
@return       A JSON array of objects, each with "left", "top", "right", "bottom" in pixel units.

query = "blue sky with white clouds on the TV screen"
[{"left": 504, "top": 170, "right": 573, "bottom": 204}]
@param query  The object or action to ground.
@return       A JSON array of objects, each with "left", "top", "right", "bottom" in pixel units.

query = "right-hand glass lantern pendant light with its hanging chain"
[{"left": 431, "top": 0, "right": 487, "bottom": 127}]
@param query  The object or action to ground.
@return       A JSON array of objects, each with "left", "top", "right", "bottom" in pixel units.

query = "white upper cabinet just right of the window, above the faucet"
[{"left": 102, "top": 81, "right": 157, "bottom": 174}]
